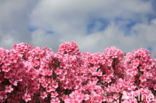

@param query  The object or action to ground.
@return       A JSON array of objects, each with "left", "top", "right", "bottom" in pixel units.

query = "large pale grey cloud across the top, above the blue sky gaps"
[{"left": 32, "top": 0, "right": 152, "bottom": 35}]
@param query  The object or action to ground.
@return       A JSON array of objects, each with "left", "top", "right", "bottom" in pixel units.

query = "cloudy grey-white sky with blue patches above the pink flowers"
[{"left": 0, "top": 0, "right": 156, "bottom": 57}]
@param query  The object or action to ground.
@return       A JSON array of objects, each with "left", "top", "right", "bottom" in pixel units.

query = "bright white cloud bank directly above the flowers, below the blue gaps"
[{"left": 76, "top": 19, "right": 156, "bottom": 57}]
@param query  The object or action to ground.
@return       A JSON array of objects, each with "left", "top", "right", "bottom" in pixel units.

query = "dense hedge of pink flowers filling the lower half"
[{"left": 0, "top": 41, "right": 156, "bottom": 103}]
